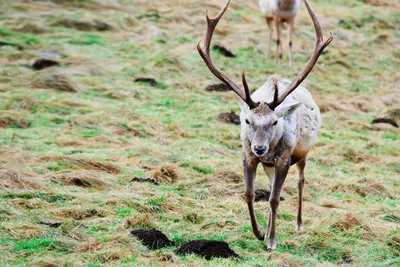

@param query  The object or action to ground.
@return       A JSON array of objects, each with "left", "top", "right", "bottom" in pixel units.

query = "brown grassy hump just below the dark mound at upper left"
[{"left": 31, "top": 71, "right": 81, "bottom": 93}]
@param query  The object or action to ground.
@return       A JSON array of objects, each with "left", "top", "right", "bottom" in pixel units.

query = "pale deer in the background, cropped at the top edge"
[{"left": 259, "top": 0, "right": 300, "bottom": 67}]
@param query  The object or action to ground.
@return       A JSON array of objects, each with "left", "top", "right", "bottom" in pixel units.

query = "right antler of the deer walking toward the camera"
[{"left": 268, "top": 0, "right": 333, "bottom": 110}]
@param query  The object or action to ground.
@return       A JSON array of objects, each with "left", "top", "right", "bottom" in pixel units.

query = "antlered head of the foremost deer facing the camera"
[{"left": 197, "top": 0, "right": 333, "bottom": 157}]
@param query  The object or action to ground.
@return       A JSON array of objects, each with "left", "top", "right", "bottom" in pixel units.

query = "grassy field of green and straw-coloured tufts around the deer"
[{"left": 0, "top": 0, "right": 400, "bottom": 266}]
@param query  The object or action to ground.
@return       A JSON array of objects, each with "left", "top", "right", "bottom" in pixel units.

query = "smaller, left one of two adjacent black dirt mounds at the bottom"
[{"left": 131, "top": 229, "right": 174, "bottom": 250}]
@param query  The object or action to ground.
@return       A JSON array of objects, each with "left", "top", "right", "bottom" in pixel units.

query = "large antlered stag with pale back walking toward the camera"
[{"left": 197, "top": 0, "right": 333, "bottom": 251}]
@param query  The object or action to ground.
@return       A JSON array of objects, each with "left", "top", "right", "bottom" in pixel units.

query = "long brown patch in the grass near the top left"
[{"left": 52, "top": 18, "right": 114, "bottom": 31}]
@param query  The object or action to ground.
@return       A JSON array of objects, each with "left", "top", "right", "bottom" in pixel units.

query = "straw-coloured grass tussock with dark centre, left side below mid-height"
[{"left": 49, "top": 171, "right": 108, "bottom": 189}]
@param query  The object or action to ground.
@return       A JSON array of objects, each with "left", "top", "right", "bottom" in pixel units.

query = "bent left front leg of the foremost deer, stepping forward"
[{"left": 243, "top": 159, "right": 264, "bottom": 240}]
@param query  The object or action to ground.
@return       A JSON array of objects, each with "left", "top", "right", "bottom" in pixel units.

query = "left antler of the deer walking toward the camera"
[{"left": 197, "top": 0, "right": 258, "bottom": 109}]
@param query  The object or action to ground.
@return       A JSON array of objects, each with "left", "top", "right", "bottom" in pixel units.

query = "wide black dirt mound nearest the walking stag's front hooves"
[{"left": 176, "top": 240, "right": 239, "bottom": 260}]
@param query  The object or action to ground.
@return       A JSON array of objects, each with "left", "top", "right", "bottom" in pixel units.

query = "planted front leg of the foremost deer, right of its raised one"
[{"left": 265, "top": 159, "right": 290, "bottom": 251}]
